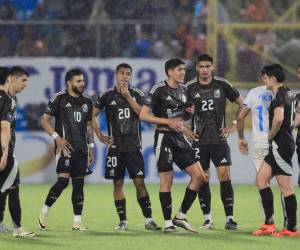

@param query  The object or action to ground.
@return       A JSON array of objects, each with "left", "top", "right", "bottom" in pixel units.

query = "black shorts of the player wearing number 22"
[{"left": 193, "top": 143, "right": 231, "bottom": 170}]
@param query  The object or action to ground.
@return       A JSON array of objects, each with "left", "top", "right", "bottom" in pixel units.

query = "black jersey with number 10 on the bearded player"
[{"left": 45, "top": 91, "right": 93, "bottom": 154}]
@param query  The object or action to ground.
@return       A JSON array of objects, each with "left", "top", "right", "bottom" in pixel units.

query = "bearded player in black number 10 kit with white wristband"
[{"left": 38, "top": 69, "right": 94, "bottom": 231}]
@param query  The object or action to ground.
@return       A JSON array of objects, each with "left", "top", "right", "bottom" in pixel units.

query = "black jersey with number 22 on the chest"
[{"left": 186, "top": 76, "right": 240, "bottom": 145}]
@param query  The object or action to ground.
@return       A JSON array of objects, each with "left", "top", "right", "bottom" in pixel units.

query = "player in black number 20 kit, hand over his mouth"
[{"left": 93, "top": 63, "right": 160, "bottom": 230}]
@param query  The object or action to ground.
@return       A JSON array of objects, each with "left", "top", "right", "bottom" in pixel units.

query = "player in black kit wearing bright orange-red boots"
[{"left": 253, "top": 64, "right": 297, "bottom": 237}]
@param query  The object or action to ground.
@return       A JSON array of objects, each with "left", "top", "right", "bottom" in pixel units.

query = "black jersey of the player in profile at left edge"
[{"left": 0, "top": 90, "right": 17, "bottom": 155}]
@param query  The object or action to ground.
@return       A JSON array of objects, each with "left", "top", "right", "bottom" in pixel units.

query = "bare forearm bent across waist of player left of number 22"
[{"left": 139, "top": 105, "right": 183, "bottom": 132}]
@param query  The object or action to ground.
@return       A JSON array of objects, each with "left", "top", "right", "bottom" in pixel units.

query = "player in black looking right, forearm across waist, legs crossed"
[{"left": 140, "top": 58, "right": 205, "bottom": 233}]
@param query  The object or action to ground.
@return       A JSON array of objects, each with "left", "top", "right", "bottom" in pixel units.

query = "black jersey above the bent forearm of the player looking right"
[{"left": 146, "top": 81, "right": 188, "bottom": 121}]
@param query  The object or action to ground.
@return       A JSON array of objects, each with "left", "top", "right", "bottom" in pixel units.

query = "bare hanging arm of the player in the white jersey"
[{"left": 237, "top": 107, "right": 250, "bottom": 155}]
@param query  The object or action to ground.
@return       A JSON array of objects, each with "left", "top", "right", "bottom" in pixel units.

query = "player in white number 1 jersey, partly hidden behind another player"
[{"left": 238, "top": 86, "right": 286, "bottom": 227}]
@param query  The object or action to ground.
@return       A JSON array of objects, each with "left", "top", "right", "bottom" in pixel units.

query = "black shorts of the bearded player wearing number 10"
[{"left": 56, "top": 152, "right": 88, "bottom": 178}]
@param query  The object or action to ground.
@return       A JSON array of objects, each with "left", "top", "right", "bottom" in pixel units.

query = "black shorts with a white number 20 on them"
[{"left": 105, "top": 148, "right": 145, "bottom": 180}]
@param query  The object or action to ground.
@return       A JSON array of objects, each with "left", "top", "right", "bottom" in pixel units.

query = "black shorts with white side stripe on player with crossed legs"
[{"left": 154, "top": 130, "right": 197, "bottom": 172}]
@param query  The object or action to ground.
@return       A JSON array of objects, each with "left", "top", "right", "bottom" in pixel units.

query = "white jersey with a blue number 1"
[{"left": 243, "top": 86, "right": 273, "bottom": 144}]
